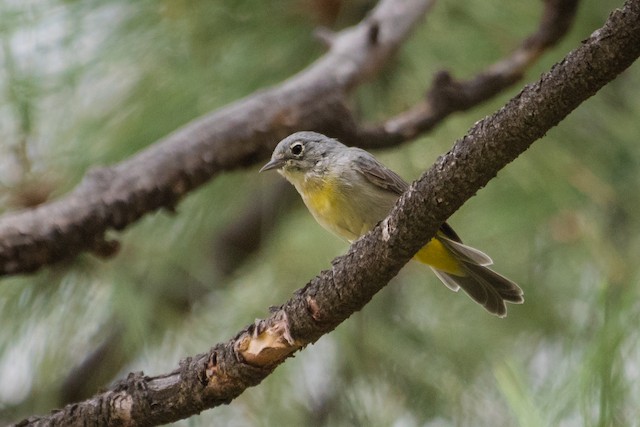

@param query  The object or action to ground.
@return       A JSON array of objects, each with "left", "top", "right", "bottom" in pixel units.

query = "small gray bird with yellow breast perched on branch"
[{"left": 260, "top": 131, "right": 524, "bottom": 317}]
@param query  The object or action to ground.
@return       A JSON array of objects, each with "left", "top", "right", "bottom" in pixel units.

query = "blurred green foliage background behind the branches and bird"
[{"left": 0, "top": 0, "right": 640, "bottom": 426}]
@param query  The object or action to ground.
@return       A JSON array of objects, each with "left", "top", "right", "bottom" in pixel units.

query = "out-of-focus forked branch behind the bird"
[{"left": 0, "top": 0, "right": 577, "bottom": 275}]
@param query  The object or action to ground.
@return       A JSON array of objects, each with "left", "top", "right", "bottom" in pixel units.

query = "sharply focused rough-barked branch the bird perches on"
[{"left": 17, "top": 0, "right": 640, "bottom": 426}]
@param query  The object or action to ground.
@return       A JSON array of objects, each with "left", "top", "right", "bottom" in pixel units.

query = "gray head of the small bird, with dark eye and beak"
[{"left": 260, "top": 132, "right": 344, "bottom": 176}]
